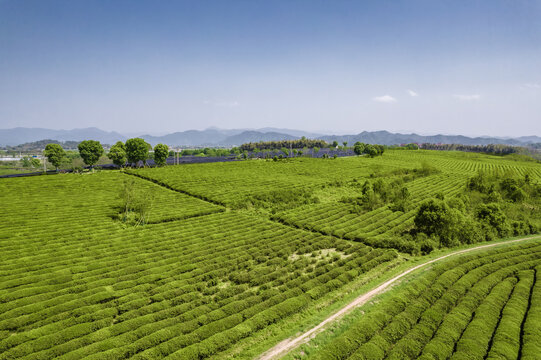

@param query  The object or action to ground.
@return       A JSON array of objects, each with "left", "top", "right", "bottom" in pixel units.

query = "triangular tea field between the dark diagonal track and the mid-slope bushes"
[{"left": 127, "top": 158, "right": 380, "bottom": 207}]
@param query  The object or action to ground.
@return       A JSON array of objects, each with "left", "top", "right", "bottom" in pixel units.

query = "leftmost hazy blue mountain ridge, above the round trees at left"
[{"left": 0, "top": 127, "right": 126, "bottom": 146}]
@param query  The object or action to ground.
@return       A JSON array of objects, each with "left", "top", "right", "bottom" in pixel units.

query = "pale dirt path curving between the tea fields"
[{"left": 259, "top": 236, "right": 539, "bottom": 360}]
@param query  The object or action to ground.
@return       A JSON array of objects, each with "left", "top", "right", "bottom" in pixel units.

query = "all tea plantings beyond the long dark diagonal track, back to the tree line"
[{"left": 129, "top": 151, "right": 541, "bottom": 252}]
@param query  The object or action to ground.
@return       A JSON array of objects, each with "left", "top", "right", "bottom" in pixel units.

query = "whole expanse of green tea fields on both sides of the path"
[{"left": 0, "top": 151, "right": 541, "bottom": 359}]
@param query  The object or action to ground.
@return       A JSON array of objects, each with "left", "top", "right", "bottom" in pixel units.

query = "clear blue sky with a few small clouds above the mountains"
[{"left": 0, "top": 0, "right": 541, "bottom": 136}]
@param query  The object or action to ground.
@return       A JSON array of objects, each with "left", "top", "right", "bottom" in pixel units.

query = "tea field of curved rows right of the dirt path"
[{"left": 305, "top": 241, "right": 541, "bottom": 360}]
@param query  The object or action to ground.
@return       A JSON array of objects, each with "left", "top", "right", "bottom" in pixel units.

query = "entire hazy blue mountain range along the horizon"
[{"left": 0, "top": 127, "right": 541, "bottom": 147}]
